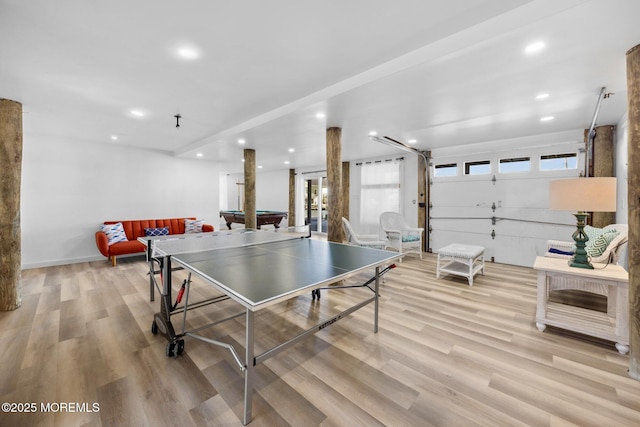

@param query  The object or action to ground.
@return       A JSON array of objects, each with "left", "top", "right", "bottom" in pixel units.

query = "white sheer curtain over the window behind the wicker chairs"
[{"left": 360, "top": 160, "right": 402, "bottom": 234}]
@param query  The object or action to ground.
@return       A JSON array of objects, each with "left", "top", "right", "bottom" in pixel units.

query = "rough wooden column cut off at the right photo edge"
[{"left": 627, "top": 41, "right": 640, "bottom": 380}]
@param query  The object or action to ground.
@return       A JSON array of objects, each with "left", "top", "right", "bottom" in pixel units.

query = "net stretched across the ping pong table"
[{"left": 151, "top": 225, "right": 310, "bottom": 257}]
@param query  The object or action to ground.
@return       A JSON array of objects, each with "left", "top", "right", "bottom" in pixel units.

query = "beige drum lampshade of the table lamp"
[{"left": 549, "top": 177, "right": 616, "bottom": 212}]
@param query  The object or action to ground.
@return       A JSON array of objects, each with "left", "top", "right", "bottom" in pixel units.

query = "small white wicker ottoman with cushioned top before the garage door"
[{"left": 436, "top": 243, "right": 484, "bottom": 286}]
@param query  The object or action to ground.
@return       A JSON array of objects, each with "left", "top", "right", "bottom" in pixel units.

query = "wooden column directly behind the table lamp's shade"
[{"left": 587, "top": 126, "right": 616, "bottom": 228}]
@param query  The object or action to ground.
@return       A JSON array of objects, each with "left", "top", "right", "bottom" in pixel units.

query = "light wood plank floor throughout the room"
[{"left": 0, "top": 254, "right": 640, "bottom": 427}]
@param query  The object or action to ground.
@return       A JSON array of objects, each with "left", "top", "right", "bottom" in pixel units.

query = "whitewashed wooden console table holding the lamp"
[{"left": 533, "top": 257, "right": 629, "bottom": 354}]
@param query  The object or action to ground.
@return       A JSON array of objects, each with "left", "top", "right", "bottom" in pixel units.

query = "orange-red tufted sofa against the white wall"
[{"left": 96, "top": 218, "right": 214, "bottom": 267}]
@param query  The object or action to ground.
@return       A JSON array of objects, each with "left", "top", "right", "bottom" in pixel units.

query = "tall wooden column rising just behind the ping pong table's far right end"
[{"left": 327, "top": 127, "right": 343, "bottom": 243}]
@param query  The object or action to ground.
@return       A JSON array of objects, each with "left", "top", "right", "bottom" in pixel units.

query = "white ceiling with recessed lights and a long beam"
[{"left": 0, "top": 0, "right": 640, "bottom": 172}]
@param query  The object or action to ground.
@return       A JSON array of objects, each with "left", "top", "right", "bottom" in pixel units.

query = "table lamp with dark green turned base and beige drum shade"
[{"left": 549, "top": 177, "right": 616, "bottom": 268}]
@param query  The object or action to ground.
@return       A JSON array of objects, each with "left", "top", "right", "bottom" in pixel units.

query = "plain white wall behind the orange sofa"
[{"left": 21, "top": 135, "right": 220, "bottom": 268}]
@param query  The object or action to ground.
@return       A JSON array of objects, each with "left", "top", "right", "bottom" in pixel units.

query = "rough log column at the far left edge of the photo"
[{"left": 0, "top": 99, "right": 22, "bottom": 312}]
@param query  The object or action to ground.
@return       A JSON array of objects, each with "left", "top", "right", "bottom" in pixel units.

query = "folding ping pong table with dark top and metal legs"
[{"left": 139, "top": 227, "right": 402, "bottom": 425}]
